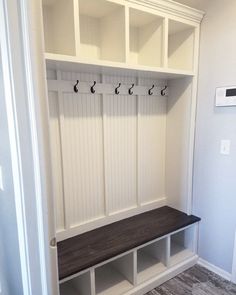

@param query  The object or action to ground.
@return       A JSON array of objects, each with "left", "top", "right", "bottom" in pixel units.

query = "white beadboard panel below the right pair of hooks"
[{"left": 138, "top": 96, "right": 166, "bottom": 204}]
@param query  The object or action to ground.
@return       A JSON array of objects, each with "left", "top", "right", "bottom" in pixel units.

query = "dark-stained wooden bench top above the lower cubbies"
[{"left": 57, "top": 206, "right": 200, "bottom": 280}]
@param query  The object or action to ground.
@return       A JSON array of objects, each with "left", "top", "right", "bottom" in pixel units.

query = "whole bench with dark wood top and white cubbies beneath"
[{"left": 58, "top": 206, "right": 200, "bottom": 295}]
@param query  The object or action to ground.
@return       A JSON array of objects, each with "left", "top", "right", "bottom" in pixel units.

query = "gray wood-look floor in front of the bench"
[{"left": 146, "top": 265, "right": 236, "bottom": 295}]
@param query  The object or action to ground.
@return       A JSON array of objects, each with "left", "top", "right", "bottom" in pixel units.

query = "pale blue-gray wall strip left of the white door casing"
[{"left": 0, "top": 52, "right": 23, "bottom": 295}]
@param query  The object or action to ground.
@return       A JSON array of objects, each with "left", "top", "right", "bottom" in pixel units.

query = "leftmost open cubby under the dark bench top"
[{"left": 60, "top": 271, "right": 92, "bottom": 295}]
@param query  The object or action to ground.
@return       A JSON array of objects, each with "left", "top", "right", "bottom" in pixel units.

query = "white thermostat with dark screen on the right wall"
[{"left": 216, "top": 86, "right": 236, "bottom": 107}]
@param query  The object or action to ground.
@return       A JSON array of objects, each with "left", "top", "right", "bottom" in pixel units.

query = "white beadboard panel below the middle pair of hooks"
[{"left": 103, "top": 95, "right": 137, "bottom": 214}]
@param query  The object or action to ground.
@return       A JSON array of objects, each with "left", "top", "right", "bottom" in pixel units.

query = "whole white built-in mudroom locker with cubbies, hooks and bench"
[{"left": 42, "top": 0, "right": 203, "bottom": 295}]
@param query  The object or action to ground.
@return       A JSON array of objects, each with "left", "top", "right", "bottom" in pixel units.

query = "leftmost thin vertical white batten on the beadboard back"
[{"left": 57, "top": 70, "right": 70, "bottom": 230}]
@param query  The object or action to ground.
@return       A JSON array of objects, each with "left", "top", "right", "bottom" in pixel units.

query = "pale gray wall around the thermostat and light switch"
[{"left": 176, "top": 0, "right": 236, "bottom": 273}]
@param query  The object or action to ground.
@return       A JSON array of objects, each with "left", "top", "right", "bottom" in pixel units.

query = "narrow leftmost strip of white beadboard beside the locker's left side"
[{"left": 48, "top": 91, "right": 65, "bottom": 231}]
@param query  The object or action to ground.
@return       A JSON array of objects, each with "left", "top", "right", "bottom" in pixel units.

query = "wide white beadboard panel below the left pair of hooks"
[{"left": 62, "top": 93, "right": 105, "bottom": 226}]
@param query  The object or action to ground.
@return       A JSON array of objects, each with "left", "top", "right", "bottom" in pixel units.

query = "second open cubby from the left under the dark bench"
[{"left": 95, "top": 253, "right": 134, "bottom": 295}]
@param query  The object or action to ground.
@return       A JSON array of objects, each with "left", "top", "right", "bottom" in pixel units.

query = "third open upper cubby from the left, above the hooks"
[{"left": 129, "top": 8, "right": 163, "bottom": 67}]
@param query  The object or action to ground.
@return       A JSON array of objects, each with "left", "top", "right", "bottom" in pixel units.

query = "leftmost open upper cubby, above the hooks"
[{"left": 43, "top": 0, "right": 76, "bottom": 55}]
